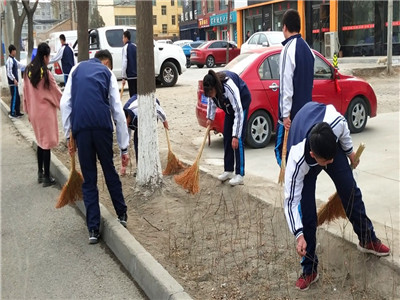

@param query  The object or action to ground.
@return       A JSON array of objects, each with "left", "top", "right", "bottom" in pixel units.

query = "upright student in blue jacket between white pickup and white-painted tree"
[{"left": 122, "top": 31, "right": 137, "bottom": 97}]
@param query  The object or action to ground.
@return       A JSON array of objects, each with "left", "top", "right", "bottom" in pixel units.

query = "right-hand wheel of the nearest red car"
[{"left": 346, "top": 97, "right": 368, "bottom": 133}]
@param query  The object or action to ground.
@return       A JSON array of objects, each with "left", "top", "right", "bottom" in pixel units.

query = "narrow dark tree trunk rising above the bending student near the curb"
[{"left": 76, "top": 0, "right": 88, "bottom": 61}]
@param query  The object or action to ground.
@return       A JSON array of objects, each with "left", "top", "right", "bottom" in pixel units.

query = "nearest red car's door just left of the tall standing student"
[{"left": 258, "top": 53, "right": 280, "bottom": 121}]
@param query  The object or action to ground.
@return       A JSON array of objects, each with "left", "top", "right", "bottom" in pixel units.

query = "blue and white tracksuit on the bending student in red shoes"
[{"left": 284, "top": 102, "right": 376, "bottom": 274}]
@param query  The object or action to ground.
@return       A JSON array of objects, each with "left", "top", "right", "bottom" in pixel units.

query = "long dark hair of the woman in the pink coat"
[{"left": 24, "top": 43, "right": 50, "bottom": 89}]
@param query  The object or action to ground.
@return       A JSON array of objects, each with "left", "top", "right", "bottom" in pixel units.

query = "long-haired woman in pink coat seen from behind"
[{"left": 24, "top": 43, "right": 62, "bottom": 187}]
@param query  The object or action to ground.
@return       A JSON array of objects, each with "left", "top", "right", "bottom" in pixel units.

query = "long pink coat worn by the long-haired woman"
[{"left": 24, "top": 71, "right": 62, "bottom": 149}]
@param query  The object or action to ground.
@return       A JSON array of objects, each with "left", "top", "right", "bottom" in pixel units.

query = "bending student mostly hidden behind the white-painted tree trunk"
[{"left": 122, "top": 95, "right": 168, "bottom": 173}]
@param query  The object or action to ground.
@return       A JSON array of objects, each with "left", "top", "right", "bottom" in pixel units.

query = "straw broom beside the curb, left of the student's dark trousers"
[{"left": 56, "top": 134, "right": 83, "bottom": 208}]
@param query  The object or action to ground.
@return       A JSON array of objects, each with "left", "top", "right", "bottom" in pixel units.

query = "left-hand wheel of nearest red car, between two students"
[{"left": 246, "top": 110, "right": 272, "bottom": 148}]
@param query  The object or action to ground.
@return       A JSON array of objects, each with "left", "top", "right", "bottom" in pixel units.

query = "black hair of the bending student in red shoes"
[{"left": 308, "top": 122, "right": 337, "bottom": 160}]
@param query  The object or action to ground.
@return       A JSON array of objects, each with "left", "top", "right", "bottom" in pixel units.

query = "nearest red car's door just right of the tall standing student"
[{"left": 312, "top": 54, "right": 342, "bottom": 111}]
